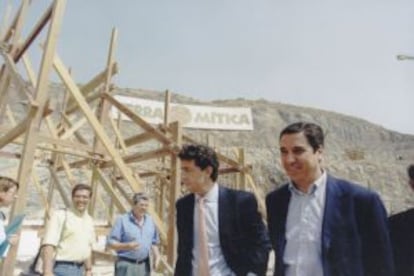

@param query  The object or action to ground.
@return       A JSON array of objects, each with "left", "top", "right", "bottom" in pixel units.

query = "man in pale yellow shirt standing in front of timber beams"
[{"left": 42, "top": 184, "right": 95, "bottom": 276}]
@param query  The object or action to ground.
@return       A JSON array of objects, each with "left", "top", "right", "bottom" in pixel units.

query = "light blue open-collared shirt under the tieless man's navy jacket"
[{"left": 283, "top": 172, "right": 326, "bottom": 276}]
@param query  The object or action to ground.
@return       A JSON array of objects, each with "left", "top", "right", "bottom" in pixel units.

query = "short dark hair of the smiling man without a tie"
[{"left": 279, "top": 122, "right": 325, "bottom": 152}]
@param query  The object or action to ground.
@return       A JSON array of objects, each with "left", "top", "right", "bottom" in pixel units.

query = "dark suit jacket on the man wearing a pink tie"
[{"left": 175, "top": 186, "right": 271, "bottom": 276}]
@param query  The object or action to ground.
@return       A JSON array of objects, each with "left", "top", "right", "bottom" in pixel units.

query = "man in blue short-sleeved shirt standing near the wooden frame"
[{"left": 108, "top": 193, "right": 160, "bottom": 276}]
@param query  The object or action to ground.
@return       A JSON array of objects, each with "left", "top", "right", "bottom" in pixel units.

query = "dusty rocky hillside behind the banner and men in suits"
[{"left": 116, "top": 89, "right": 414, "bottom": 213}]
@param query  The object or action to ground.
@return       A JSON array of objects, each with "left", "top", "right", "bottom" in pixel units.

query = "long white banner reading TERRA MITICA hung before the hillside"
[{"left": 113, "top": 95, "right": 253, "bottom": 130}]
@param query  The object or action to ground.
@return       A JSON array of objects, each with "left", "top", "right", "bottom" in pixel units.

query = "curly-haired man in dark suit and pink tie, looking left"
[{"left": 175, "top": 145, "right": 271, "bottom": 276}]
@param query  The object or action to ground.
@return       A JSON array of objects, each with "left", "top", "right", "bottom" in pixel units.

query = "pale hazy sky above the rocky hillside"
[{"left": 0, "top": 0, "right": 414, "bottom": 134}]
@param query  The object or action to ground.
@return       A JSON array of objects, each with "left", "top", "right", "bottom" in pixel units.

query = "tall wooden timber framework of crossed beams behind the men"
[{"left": 0, "top": 0, "right": 264, "bottom": 276}]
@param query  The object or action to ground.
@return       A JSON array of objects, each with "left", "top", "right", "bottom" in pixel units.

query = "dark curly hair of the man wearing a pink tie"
[{"left": 178, "top": 144, "right": 220, "bottom": 181}]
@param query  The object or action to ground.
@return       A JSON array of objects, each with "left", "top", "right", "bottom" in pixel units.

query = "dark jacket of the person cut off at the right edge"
[{"left": 389, "top": 209, "right": 414, "bottom": 276}]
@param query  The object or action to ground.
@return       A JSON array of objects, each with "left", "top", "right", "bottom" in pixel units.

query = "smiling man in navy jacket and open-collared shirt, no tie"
[{"left": 266, "top": 122, "right": 394, "bottom": 276}]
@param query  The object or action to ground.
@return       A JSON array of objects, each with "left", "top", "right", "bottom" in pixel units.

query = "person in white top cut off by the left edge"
[{"left": 0, "top": 176, "right": 19, "bottom": 252}]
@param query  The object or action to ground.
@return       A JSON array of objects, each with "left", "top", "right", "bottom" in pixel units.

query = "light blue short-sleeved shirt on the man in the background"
[{"left": 108, "top": 212, "right": 160, "bottom": 261}]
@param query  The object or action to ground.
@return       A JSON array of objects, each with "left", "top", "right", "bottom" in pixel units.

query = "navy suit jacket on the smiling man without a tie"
[{"left": 266, "top": 175, "right": 394, "bottom": 276}]
